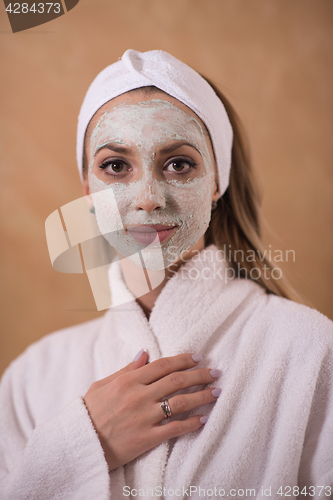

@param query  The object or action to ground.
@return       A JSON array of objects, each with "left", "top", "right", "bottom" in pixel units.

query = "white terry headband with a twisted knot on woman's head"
[{"left": 76, "top": 49, "right": 233, "bottom": 196}]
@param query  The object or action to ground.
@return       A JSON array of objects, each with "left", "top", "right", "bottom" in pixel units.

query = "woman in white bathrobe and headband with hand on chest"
[{"left": 0, "top": 50, "right": 333, "bottom": 500}]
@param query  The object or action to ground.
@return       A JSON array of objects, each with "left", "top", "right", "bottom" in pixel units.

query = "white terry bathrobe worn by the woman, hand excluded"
[{"left": 0, "top": 245, "right": 333, "bottom": 500}]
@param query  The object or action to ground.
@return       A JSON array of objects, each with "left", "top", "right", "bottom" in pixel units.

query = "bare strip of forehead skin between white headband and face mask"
[{"left": 86, "top": 88, "right": 209, "bottom": 141}]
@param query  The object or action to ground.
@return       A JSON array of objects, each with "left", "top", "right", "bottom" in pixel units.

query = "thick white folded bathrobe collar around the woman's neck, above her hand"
[{"left": 94, "top": 245, "right": 264, "bottom": 376}]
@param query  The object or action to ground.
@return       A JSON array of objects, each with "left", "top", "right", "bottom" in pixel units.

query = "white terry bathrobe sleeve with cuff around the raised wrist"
[{"left": 0, "top": 352, "right": 110, "bottom": 500}]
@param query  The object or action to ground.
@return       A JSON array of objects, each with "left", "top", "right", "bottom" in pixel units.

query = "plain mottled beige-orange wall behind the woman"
[{"left": 0, "top": 0, "right": 333, "bottom": 373}]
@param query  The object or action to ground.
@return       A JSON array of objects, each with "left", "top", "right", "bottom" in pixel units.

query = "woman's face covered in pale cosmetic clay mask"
[{"left": 85, "top": 90, "right": 218, "bottom": 270}]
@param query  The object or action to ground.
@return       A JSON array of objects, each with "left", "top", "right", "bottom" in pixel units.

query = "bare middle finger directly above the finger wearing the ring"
[{"left": 150, "top": 368, "right": 221, "bottom": 401}]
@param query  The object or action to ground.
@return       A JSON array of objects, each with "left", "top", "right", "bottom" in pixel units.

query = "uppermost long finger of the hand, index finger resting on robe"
[{"left": 136, "top": 353, "right": 202, "bottom": 384}]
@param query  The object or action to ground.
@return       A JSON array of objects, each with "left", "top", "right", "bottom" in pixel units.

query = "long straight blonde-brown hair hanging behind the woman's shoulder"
[{"left": 203, "top": 77, "right": 300, "bottom": 300}]
